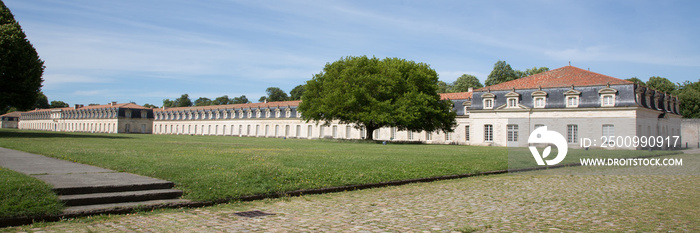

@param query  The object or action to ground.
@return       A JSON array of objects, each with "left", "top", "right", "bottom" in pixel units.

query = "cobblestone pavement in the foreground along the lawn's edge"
[{"left": 4, "top": 157, "right": 700, "bottom": 232}]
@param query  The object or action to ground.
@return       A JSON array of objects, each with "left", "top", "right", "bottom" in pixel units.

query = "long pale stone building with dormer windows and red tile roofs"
[{"left": 13, "top": 66, "right": 682, "bottom": 149}]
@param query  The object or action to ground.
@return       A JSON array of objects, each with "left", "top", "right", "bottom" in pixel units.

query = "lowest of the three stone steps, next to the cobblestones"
[{"left": 63, "top": 199, "right": 190, "bottom": 216}]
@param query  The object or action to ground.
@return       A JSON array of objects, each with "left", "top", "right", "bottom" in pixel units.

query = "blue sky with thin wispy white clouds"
[{"left": 4, "top": 0, "right": 700, "bottom": 106}]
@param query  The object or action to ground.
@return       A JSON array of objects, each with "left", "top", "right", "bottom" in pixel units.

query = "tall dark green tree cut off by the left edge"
[{"left": 0, "top": 1, "right": 44, "bottom": 112}]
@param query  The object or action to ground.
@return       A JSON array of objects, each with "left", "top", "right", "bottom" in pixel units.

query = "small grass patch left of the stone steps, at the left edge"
[{"left": 0, "top": 167, "right": 63, "bottom": 218}]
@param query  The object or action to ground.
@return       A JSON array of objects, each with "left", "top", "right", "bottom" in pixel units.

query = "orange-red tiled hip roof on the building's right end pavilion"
[{"left": 475, "top": 66, "right": 633, "bottom": 91}]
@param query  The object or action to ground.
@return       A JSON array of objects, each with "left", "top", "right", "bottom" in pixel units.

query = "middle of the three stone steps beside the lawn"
[{"left": 58, "top": 189, "right": 182, "bottom": 206}]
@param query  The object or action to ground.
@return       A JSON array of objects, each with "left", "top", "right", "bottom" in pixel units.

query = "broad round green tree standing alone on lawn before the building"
[{"left": 299, "top": 56, "right": 456, "bottom": 139}]
